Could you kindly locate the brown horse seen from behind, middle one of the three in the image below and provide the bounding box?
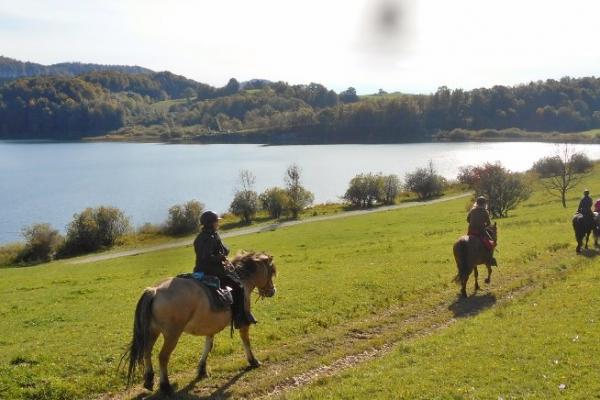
[453,223,498,297]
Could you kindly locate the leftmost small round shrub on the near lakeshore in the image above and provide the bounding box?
[16,224,63,264]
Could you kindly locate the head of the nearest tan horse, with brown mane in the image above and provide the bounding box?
[232,252,277,297]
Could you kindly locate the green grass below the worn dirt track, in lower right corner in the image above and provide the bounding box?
[287,263,600,399]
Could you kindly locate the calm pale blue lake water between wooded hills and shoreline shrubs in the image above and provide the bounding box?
[0,141,600,243]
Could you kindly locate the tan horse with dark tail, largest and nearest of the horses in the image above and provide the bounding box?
[124,253,276,393]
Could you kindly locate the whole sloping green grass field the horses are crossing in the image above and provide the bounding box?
[0,171,600,399]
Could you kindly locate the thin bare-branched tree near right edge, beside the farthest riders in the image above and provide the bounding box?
[540,143,592,208]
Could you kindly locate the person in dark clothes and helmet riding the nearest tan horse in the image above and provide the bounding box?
[194,211,256,329]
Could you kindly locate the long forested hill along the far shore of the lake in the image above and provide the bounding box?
[0,55,600,143]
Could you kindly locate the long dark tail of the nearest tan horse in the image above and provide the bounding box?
[121,288,156,387]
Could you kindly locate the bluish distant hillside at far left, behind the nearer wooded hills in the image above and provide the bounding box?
[0,56,153,80]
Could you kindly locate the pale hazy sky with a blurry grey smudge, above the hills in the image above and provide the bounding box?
[0,0,600,93]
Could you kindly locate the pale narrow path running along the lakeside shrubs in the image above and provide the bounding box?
[69,193,471,264]
